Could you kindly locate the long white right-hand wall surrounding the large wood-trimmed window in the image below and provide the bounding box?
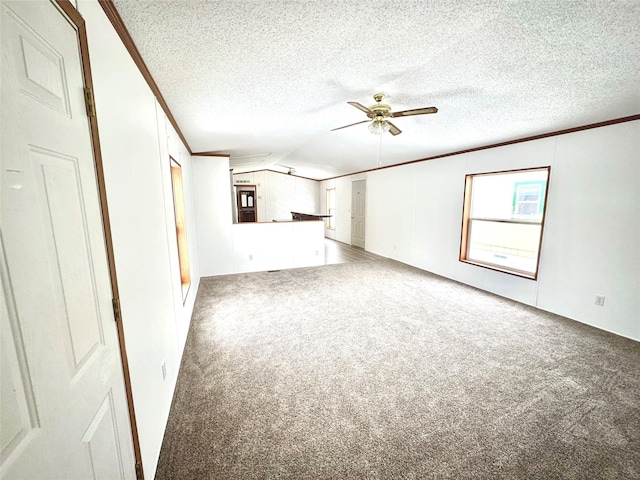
[348,121,640,340]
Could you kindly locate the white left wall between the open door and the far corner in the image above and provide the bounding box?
[78,0,200,472]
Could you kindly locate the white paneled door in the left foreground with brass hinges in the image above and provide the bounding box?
[0,0,135,479]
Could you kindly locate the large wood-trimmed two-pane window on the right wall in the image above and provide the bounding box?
[460,167,550,279]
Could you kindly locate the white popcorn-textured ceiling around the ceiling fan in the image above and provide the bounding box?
[114,0,640,179]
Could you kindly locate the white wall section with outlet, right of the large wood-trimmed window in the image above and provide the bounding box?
[538,122,640,340]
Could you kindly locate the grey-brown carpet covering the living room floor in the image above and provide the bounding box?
[156,260,640,479]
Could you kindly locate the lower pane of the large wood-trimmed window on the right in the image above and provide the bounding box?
[467,220,542,274]
